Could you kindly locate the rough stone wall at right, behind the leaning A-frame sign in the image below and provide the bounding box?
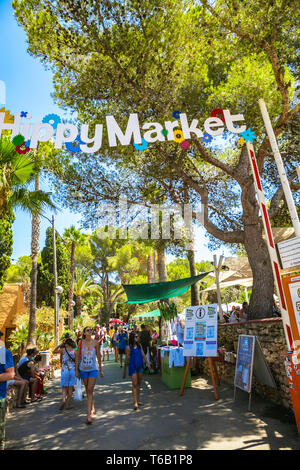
[204,318,292,409]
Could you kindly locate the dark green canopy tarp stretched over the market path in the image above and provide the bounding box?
[123,271,211,304]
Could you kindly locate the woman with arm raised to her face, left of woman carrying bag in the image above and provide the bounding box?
[53,338,76,410]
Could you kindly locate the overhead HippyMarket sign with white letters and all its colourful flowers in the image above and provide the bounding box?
[0,108,255,153]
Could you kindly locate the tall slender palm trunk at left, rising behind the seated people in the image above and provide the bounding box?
[27,174,40,347]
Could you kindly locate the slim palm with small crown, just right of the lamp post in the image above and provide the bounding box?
[63,225,86,330]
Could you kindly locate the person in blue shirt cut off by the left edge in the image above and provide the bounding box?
[0,331,15,450]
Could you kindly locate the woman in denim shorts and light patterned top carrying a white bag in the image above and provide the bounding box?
[75,327,104,424]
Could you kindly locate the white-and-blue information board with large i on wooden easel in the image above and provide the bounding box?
[183,304,218,357]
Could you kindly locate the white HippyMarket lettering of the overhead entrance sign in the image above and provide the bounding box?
[0,109,251,153]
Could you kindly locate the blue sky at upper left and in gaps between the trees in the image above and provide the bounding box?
[0,0,230,261]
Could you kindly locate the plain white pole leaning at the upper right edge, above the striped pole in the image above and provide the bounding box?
[258,99,300,237]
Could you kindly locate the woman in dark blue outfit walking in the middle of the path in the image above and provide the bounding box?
[123,333,151,410]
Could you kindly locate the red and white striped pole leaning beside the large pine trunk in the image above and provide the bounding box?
[246,141,295,351]
